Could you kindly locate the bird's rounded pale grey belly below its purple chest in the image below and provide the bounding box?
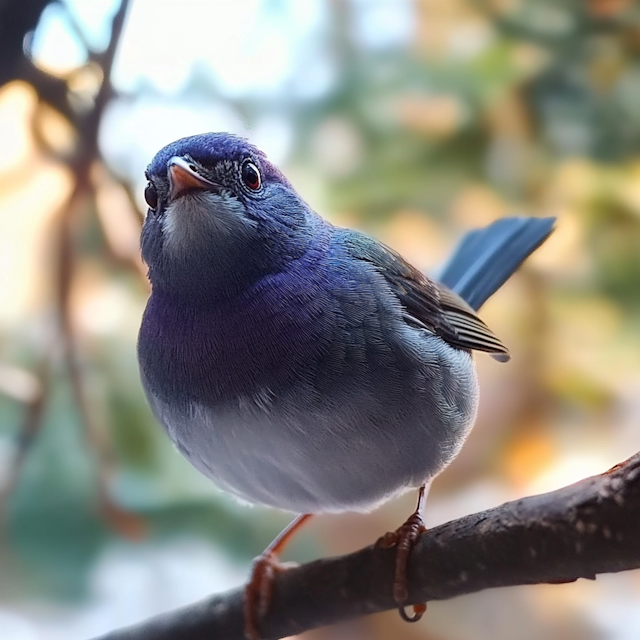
[150,329,478,513]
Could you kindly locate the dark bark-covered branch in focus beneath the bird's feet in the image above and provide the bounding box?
[90,453,640,640]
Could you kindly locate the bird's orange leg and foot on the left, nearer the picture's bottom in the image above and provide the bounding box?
[244,513,311,640]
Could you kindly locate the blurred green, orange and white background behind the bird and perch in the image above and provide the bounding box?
[0,0,640,640]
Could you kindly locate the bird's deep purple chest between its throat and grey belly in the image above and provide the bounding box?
[138,279,331,404]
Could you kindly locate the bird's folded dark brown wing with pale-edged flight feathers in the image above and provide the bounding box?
[338,229,510,362]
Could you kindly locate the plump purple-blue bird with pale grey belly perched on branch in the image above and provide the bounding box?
[137,132,555,640]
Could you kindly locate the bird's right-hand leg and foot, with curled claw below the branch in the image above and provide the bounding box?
[376,483,431,622]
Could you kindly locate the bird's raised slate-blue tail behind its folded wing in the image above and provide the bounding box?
[439,218,556,311]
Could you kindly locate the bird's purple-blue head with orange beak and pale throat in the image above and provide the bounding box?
[142,133,315,299]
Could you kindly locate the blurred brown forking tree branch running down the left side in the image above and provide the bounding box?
[0,0,142,536]
